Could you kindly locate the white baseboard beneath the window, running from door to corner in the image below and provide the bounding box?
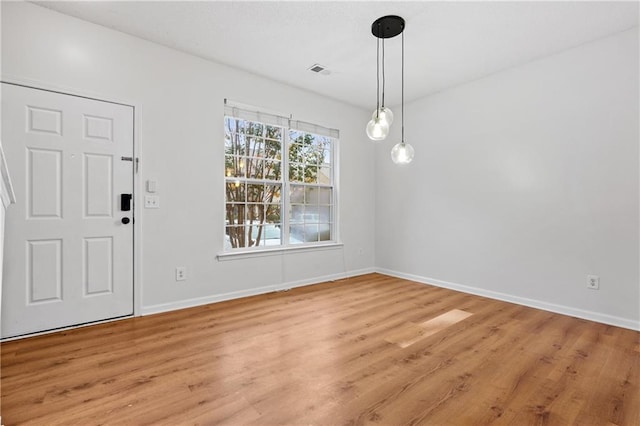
[141,268,376,315]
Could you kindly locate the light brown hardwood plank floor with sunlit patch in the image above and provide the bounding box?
[0,274,640,426]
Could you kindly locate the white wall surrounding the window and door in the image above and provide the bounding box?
[2,2,374,312]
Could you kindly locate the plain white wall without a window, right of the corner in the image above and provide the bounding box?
[376,27,640,329]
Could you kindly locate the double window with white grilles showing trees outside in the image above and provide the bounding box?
[224,102,338,251]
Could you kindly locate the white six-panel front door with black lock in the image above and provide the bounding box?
[1,83,134,338]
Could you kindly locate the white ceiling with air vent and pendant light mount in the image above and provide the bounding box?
[36,1,639,109]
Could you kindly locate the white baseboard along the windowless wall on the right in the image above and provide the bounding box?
[376,268,640,331]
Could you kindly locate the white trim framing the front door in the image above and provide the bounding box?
[0,75,144,330]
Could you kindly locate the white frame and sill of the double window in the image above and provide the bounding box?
[217,100,342,260]
